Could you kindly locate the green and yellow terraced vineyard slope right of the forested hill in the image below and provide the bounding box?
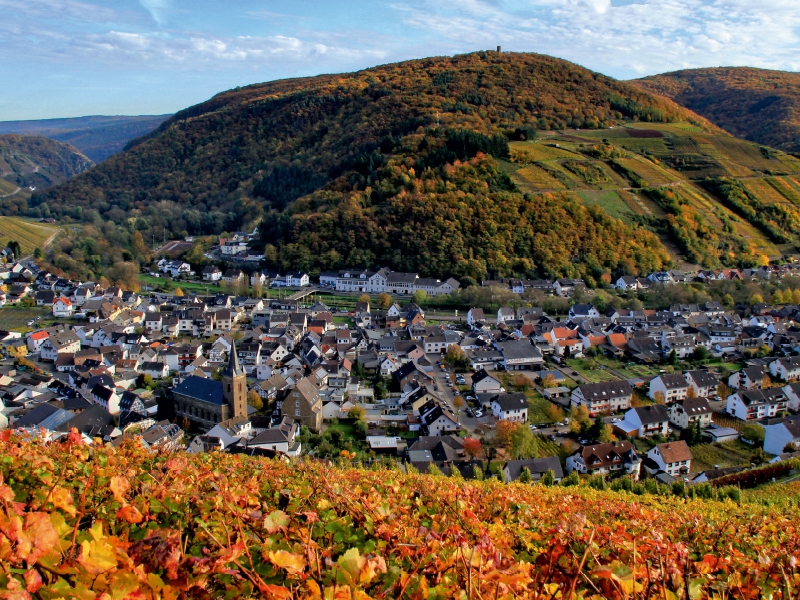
[510,123,800,268]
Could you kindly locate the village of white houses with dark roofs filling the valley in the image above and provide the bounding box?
[0,254,800,492]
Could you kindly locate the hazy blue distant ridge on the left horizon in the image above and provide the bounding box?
[0,115,169,163]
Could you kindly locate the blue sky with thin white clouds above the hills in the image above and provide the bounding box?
[0,0,800,121]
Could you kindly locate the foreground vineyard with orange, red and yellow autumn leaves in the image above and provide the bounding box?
[0,431,800,600]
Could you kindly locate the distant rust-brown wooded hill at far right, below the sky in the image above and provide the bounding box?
[631,67,800,152]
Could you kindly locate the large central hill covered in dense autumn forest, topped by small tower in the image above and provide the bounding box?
[25,52,716,284]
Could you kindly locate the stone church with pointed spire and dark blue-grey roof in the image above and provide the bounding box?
[174,346,247,430]
